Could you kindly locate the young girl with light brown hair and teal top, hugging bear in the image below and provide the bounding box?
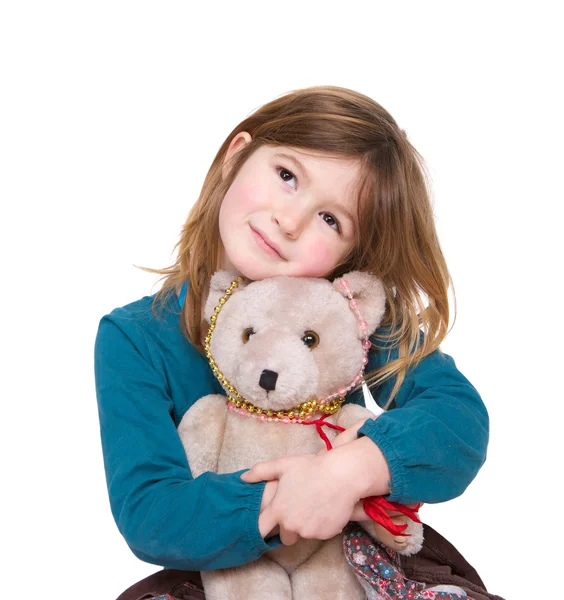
[95,86,488,584]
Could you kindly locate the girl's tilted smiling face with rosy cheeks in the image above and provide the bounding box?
[219,132,360,280]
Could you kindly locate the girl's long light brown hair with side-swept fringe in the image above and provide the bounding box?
[139,86,454,406]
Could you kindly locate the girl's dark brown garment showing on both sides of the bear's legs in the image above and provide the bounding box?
[117,525,503,600]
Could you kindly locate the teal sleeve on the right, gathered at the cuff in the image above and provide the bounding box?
[359,340,489,503]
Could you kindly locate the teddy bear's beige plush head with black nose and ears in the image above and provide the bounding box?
[205,271,386,410]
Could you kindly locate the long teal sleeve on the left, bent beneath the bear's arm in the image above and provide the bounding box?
[95,309,280,570]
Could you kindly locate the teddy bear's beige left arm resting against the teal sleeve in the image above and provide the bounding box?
[178,394,227,477]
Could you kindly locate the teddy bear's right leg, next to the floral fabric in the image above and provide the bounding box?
[290,534,366,600]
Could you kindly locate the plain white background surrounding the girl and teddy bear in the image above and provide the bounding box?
[0,0,564,600]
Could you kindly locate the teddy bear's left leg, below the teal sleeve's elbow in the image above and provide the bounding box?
[202,556,292,600]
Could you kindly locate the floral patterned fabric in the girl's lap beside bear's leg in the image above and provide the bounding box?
[343,524,472,600]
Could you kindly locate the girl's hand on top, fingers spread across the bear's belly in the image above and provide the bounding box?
[241,452,359,546]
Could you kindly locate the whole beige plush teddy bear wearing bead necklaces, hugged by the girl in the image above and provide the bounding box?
[178,271,422,600]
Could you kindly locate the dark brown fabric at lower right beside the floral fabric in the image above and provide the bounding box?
[401,524,503,600]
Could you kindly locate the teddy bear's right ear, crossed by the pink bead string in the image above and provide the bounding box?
[333,271,386,338]
